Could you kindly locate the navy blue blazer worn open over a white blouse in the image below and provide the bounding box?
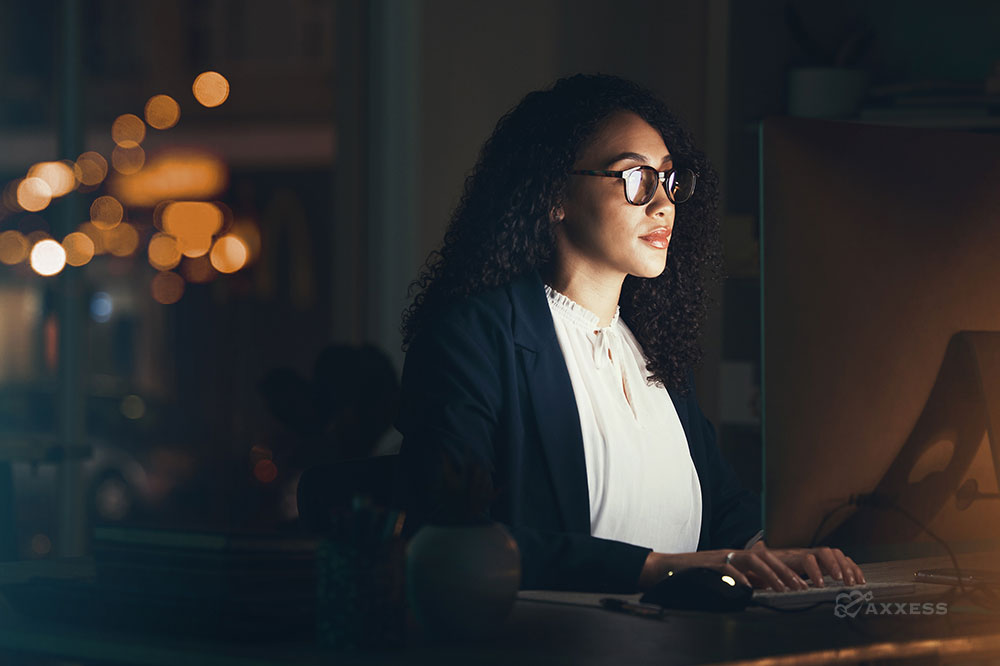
[395,271,761,594]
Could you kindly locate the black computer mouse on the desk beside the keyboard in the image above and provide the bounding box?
[639,567,753,612]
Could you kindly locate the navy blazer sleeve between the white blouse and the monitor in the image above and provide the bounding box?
[689,373,762,550]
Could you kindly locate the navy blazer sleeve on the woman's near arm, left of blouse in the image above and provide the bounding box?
[396,310,652,594]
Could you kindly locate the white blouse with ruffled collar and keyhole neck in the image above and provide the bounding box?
[545,285,701,553]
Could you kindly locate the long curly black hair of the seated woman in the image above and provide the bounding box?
[401,74,723,395]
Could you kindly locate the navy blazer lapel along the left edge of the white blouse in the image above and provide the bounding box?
[510,270,590,534]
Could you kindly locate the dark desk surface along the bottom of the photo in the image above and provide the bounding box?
[0,553,1000,666]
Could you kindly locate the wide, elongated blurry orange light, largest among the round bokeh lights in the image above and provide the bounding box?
[109,149,229,208]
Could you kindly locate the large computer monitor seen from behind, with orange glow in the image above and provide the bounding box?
[760,118,1000,562]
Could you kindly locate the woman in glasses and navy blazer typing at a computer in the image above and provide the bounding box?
[396,75,864,593]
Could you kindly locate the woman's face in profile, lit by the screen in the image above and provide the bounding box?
[556,111,674,279]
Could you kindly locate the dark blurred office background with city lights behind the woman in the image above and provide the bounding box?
[0,0,1000,559]
